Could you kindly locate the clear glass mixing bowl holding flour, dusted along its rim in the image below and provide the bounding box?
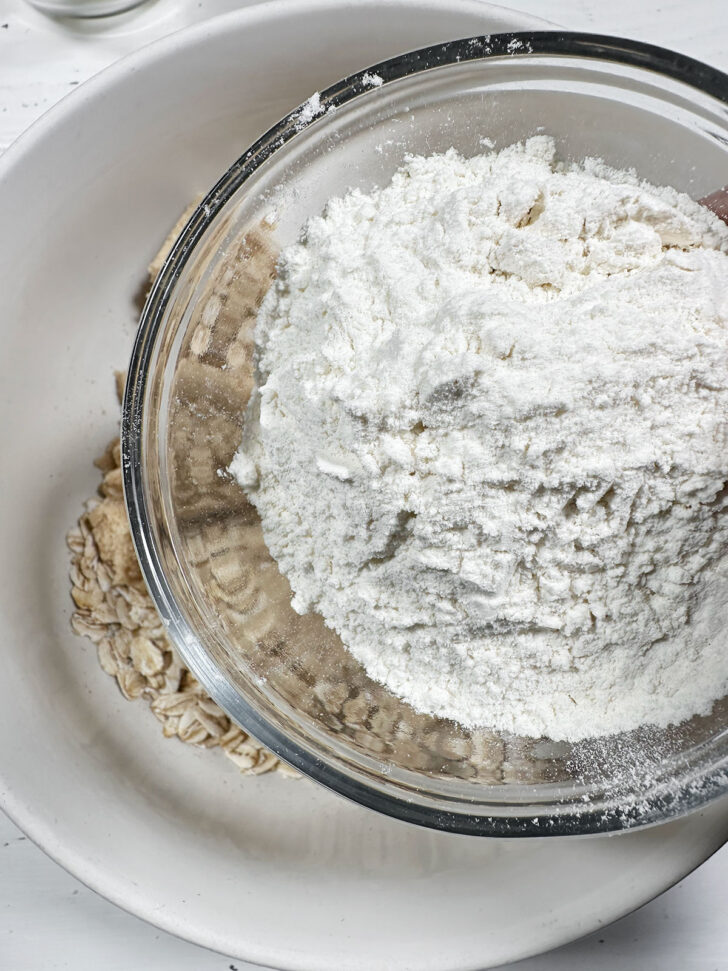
[123,32,728,836]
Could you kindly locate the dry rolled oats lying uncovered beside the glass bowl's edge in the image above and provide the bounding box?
[67,207,298,777]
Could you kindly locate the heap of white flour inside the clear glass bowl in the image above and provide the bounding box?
[232,137,728,740]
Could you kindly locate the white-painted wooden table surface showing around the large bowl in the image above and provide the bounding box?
[0,0,728,971]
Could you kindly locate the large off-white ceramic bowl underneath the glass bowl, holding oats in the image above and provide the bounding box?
[0,0,728,971]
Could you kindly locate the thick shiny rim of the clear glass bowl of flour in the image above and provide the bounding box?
[121,31,728,837]
